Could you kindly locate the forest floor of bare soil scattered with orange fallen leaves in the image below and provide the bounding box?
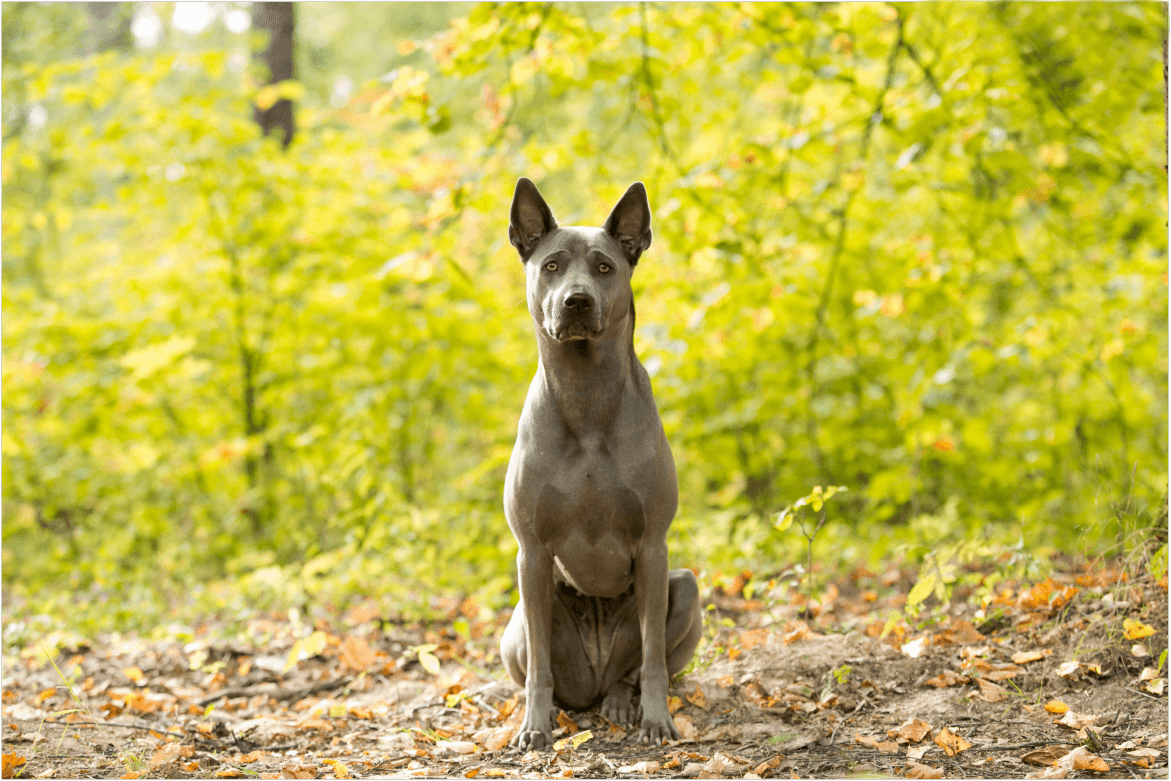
[0,562,1167,779]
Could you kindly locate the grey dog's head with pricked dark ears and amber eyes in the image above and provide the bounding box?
[508,178,651,342]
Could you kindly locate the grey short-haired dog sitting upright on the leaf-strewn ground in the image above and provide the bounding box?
[500,178,703,749]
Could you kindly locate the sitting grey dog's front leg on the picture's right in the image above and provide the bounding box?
[635,540,679,746]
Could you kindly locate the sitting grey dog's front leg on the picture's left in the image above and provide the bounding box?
[512,547,553,749]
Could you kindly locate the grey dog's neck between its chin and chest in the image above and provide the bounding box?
[536,313,635,437]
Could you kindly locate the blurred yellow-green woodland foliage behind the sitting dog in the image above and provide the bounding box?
[2,2,1167,642]
